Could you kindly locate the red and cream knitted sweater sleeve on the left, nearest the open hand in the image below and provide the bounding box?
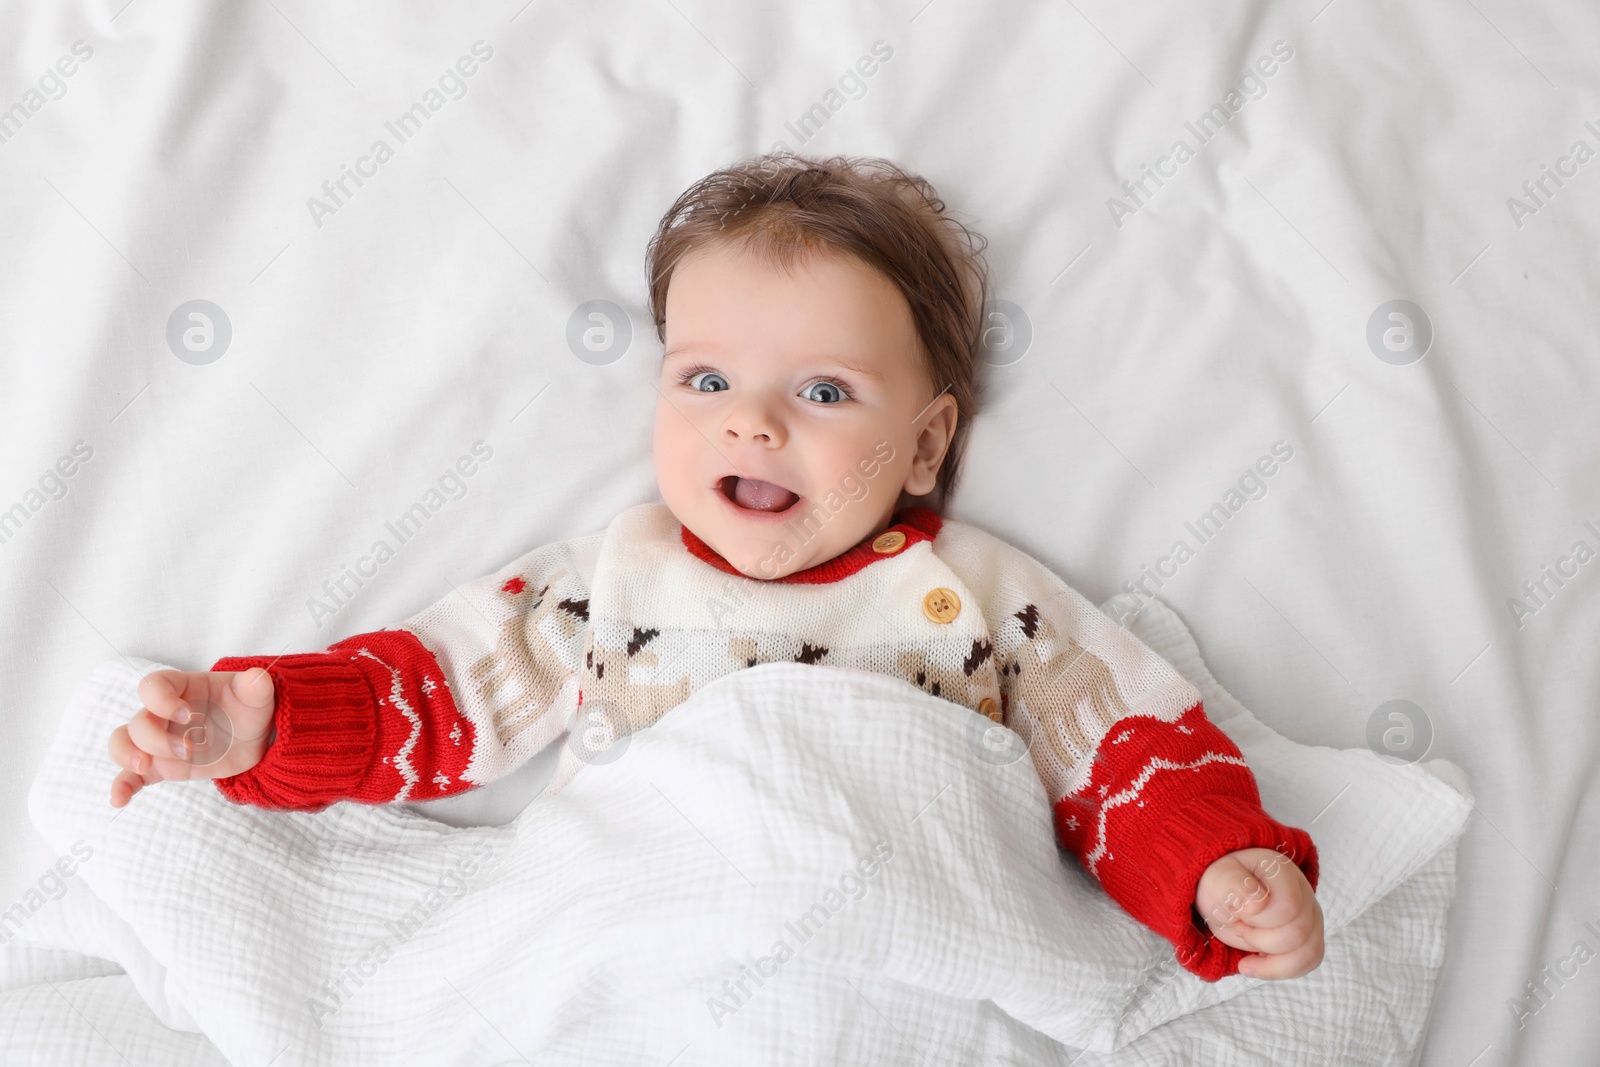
[211,534,600,811]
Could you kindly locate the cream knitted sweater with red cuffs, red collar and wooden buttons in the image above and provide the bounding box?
[211,504,1317,981]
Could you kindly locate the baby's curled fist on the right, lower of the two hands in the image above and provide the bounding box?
[1195,848,1322,977]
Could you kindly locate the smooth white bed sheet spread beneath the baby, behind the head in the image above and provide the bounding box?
[0,0,1600,1067]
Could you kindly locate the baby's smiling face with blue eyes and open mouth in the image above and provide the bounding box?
[654,246,955,579]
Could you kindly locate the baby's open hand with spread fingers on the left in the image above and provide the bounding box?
[110,667,274,808]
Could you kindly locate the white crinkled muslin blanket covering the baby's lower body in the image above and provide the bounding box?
[0,601,1470,1067]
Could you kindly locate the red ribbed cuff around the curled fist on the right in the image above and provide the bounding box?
[1102,793,1317,982]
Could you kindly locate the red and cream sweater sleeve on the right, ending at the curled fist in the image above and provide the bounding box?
[953,534,1317,982]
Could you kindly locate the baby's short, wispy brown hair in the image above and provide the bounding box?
[646,152,987,506]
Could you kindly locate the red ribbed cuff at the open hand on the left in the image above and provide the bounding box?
[211,653,378,811]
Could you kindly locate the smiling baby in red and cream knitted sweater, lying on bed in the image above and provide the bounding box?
[110,154,1323,981]
